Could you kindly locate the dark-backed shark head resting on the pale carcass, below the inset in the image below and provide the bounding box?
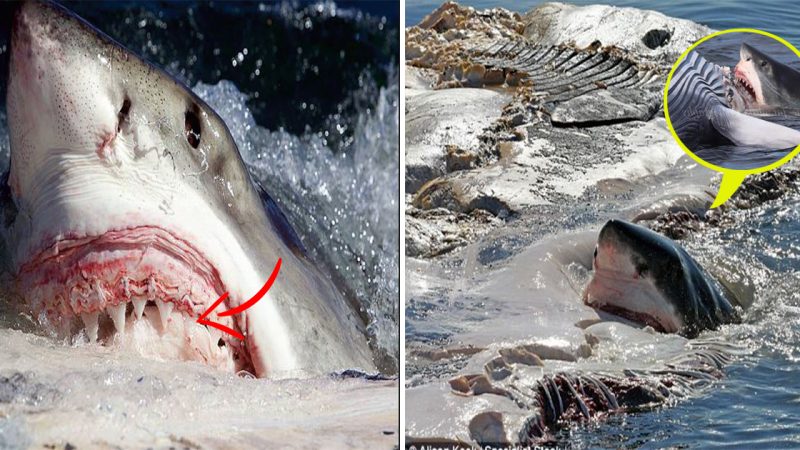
[583,220,736,336]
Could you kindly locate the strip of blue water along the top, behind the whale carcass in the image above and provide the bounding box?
[406,0,800,46]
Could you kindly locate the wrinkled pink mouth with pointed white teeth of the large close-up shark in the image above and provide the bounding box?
[18,226,254,373]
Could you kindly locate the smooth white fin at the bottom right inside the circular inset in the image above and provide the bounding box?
[708,105,800,149]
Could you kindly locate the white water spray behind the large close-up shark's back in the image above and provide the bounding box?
[194,68,399,373]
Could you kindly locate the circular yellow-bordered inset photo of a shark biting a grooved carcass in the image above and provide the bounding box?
[664,30,800,171]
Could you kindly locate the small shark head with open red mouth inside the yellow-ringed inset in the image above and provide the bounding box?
[734,43,800,108]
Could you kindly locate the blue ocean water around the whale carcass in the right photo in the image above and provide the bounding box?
[406,0,800,449]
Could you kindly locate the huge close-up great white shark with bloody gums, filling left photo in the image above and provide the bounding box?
[3,1,375,378]
